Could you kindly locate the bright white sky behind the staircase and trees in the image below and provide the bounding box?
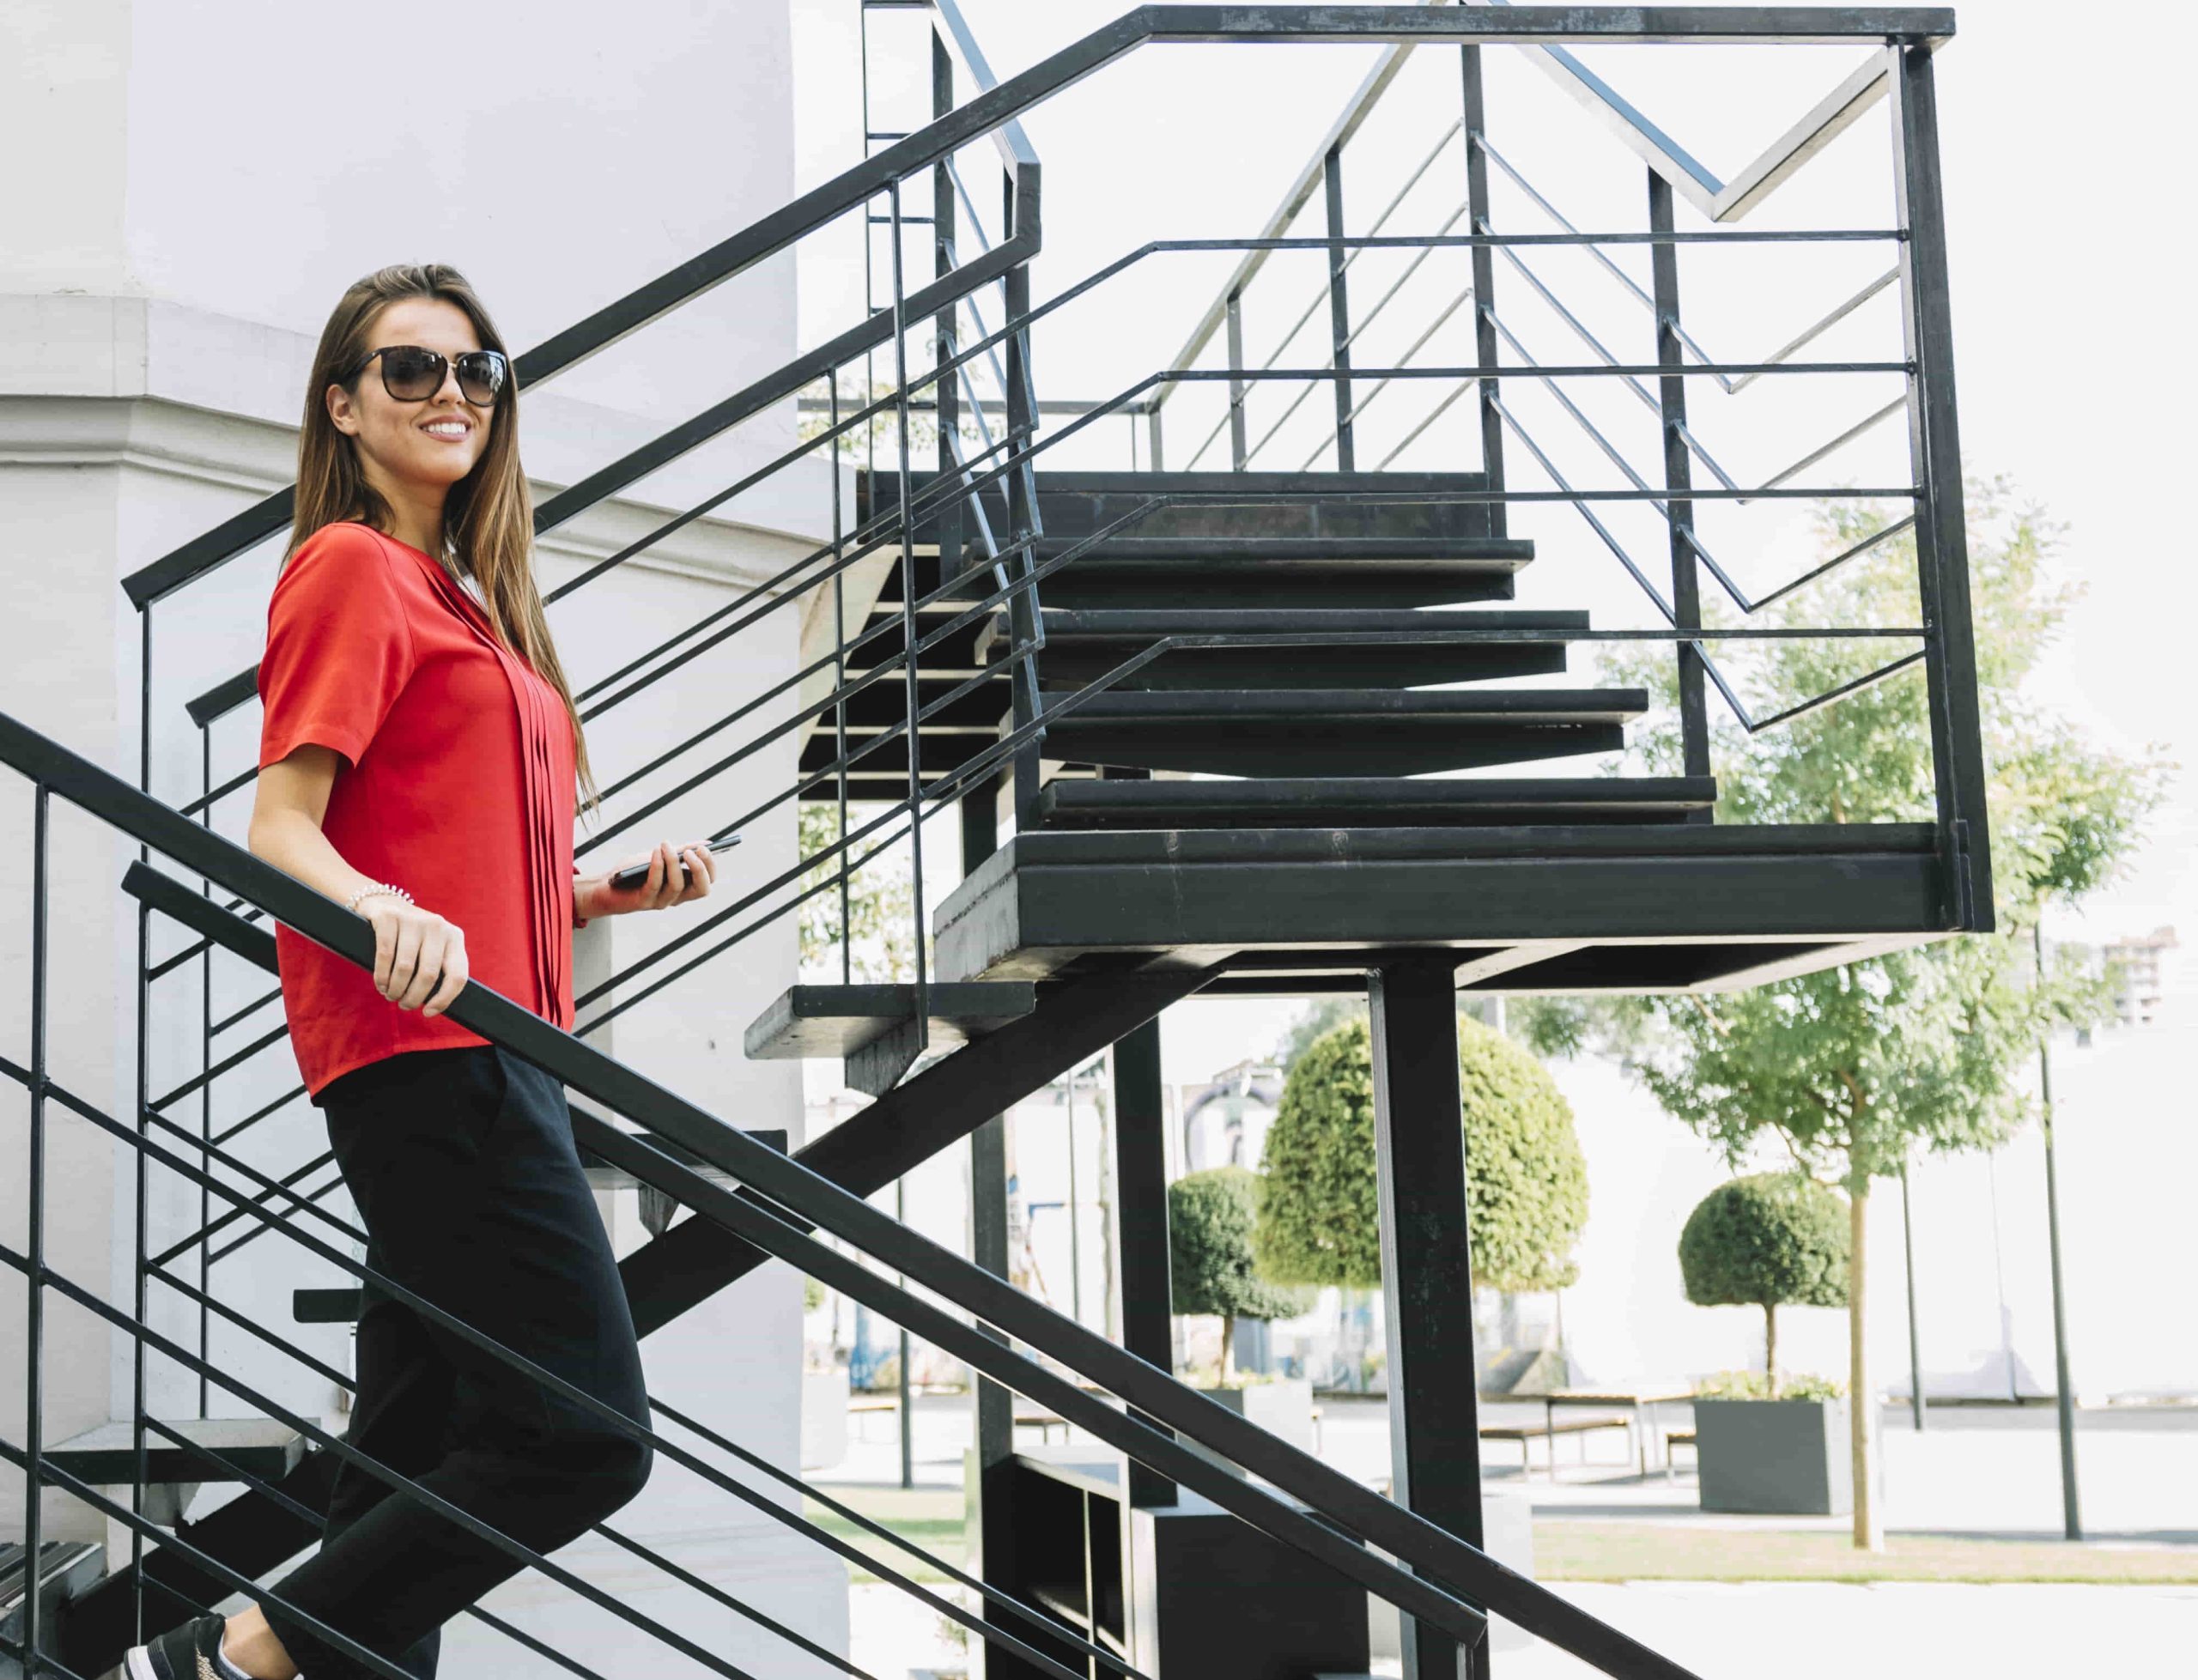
[793,0,2198,1387]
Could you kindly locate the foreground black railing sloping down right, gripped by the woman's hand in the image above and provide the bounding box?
[0,714,1714,1680]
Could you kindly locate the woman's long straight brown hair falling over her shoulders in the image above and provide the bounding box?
[282,262,596,810]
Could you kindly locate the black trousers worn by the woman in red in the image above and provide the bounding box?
[262,1045,653,1680]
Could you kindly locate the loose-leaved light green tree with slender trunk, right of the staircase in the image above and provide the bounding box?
[1515,479,2170,1550]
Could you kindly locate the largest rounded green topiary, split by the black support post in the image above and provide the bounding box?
[1253,1016,1587,1291]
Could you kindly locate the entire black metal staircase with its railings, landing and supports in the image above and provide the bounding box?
[0,0,1991,1680]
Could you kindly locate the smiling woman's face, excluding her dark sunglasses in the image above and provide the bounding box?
[327,297,490,506]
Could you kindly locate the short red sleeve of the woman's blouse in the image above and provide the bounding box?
[259,521,413,770]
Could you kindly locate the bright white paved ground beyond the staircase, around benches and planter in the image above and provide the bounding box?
[811,1397,2198,1680]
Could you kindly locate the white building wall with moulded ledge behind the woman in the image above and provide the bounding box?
[0,0,851,1676]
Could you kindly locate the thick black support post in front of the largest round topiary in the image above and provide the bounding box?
[1367,955,1488,1680]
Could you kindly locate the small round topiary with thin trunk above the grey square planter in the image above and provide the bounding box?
[1679,1172,1846,1401]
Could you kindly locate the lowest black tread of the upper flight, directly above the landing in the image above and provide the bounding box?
[1037,776,1716,829]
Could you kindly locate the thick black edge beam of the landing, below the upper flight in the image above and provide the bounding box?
[938,822,1943,979]
